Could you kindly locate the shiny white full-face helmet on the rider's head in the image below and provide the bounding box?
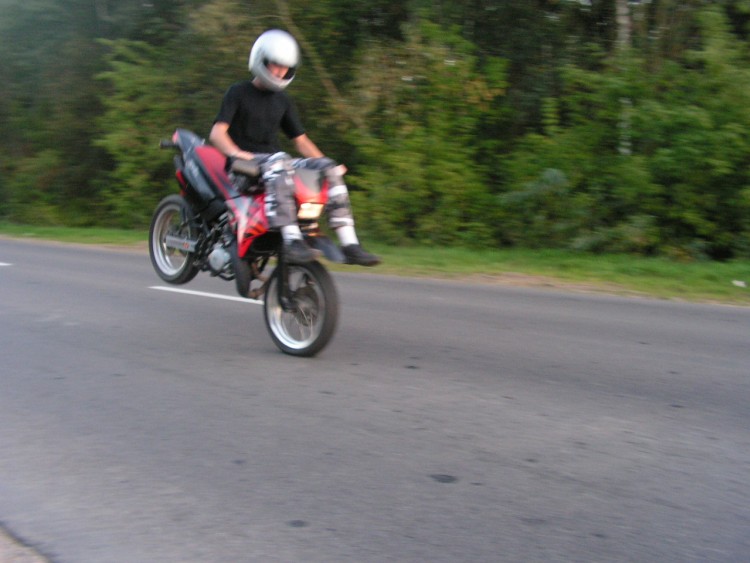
[248,29,299,92]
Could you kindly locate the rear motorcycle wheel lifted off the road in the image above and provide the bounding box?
[148,195,199,284]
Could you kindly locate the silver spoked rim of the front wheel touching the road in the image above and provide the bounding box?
[266,266,325,350]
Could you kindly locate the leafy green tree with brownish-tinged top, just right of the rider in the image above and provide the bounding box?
[350,20,505,246]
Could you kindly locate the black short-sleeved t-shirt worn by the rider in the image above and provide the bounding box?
[214,80,305,153]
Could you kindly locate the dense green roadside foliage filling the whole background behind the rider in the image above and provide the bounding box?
[0,0,750,259]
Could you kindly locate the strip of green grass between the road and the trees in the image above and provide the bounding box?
[0,223,750,306]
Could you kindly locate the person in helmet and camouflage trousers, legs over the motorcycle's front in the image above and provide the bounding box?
[209,29,380,266]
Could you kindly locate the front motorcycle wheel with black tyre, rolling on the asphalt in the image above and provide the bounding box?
[263,262,339,357]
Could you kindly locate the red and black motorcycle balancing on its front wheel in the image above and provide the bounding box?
[149,129,344,357]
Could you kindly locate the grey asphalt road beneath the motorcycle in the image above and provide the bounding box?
[0,240,750,563]
